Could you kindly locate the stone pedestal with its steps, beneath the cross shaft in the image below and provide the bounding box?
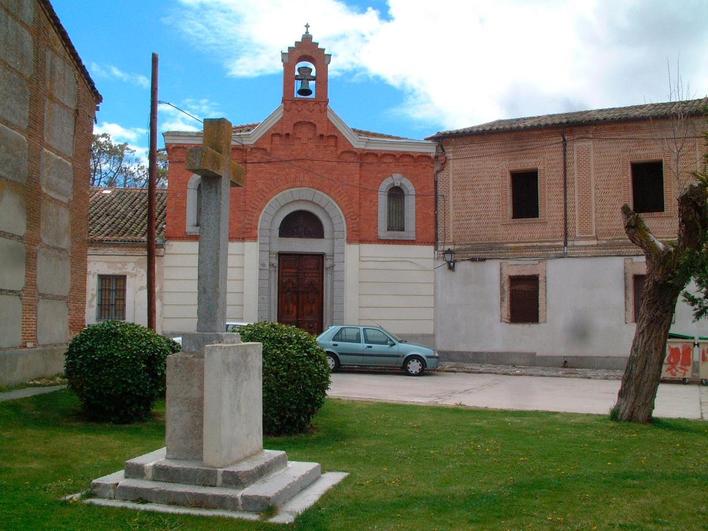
[89,333,345,521]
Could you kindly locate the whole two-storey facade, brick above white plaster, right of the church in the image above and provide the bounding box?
[433,100,708,369]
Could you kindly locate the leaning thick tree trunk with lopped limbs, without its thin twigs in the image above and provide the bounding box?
[612,120,708,422]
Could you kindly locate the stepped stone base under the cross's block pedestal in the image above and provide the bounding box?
[91,448,332,513]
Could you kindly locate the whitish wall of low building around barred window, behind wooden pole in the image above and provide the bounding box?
[86,247,163,332]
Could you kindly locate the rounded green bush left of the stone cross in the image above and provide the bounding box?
[64,321,180,423]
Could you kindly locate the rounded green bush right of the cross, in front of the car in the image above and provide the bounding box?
[238,323,329,435]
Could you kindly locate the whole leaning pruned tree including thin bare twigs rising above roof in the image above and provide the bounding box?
[611,86,708,422]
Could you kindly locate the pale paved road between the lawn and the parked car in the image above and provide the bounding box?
[329,372,708,419]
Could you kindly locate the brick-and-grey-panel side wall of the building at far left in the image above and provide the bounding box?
[0,0,100,384]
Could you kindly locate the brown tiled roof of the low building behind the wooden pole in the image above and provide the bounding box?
[88,188,167,243]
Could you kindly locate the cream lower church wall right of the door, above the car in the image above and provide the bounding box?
[356,244,435,335]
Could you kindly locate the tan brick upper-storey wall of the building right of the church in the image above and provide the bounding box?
[438,117,705,257]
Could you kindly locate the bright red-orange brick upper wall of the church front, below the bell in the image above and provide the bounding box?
[166,101,435,245]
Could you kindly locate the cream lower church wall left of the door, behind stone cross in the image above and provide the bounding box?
[162,242,246,333]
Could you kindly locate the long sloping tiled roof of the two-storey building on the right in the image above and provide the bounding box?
[428,98,708,140]
